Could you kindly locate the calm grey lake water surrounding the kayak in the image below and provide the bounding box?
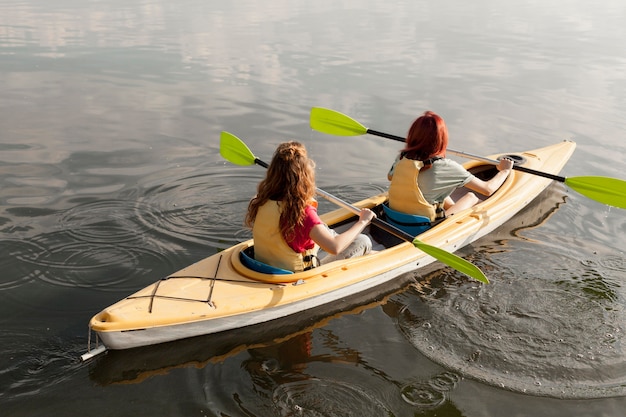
[0,0,626,417]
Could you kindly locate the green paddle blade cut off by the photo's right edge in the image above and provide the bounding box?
[564,176,626,209]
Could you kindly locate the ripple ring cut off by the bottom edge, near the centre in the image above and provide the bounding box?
[272,378,391,417]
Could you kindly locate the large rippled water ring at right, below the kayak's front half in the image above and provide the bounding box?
[398,245,626,398]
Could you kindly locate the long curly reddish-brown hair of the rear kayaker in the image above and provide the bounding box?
[245,141,315,241]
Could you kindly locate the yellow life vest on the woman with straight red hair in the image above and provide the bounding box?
[389,158,443,222]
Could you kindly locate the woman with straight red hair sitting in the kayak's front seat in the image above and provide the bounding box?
[387,111,513,222]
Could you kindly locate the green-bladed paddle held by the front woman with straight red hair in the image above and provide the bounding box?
[310,107,626,208]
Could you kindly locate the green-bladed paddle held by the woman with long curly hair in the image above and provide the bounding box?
[220,132,489,284]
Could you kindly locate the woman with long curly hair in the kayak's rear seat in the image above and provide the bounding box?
[245,141,375,272]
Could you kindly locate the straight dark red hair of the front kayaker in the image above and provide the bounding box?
[402,111,448,161]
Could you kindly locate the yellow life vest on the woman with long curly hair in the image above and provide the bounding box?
[252,200,319,272]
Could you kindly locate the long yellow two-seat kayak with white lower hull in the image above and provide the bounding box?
[83,141,576,356]
